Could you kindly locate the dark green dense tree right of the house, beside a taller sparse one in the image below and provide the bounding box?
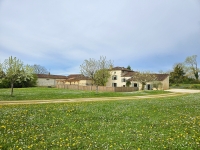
[169,63,185,84]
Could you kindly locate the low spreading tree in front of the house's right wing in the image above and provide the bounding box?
[132,71,157,90]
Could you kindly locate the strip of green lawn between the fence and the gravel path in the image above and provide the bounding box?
[0,88,170,101]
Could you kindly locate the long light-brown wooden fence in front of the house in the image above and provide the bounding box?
[57,84,138,92]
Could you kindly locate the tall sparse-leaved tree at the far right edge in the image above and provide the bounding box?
[184,55,200,80]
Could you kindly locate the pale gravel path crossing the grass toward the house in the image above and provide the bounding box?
[0,91,188,105]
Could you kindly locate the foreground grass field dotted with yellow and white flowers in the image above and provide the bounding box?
[0,94,200,150]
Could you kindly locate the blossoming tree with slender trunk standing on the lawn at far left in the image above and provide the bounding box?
[0,56,33,96]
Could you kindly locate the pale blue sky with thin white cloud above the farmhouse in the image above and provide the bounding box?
[0,0,200,75]
